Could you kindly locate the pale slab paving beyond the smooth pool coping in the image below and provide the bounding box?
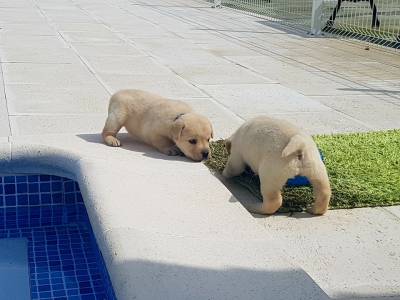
[0,0,400,299]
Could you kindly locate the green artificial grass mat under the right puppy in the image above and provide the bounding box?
[206,130,400,212]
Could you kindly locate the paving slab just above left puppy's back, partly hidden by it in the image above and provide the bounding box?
[97,73,206,98]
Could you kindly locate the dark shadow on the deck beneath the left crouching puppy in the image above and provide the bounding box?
[77,133,196,163]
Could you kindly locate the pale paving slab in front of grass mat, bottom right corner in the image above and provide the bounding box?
[256,208,400,299]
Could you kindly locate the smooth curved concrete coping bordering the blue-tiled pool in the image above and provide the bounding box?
[1,134,329,299]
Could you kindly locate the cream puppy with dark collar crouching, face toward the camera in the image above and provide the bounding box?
[102,90,213,161]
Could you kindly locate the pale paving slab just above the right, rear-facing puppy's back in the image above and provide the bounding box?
[201,84,331,119]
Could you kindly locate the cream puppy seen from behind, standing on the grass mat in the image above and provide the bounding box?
[222,116,331,215]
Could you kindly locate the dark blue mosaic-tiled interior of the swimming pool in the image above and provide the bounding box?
[0,175,116,300]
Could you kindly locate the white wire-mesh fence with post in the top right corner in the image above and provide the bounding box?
[211,0,400,49]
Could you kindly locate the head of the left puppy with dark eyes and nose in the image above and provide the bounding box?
[172,113,213,161]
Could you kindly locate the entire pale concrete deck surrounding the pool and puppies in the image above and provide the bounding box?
[0,0,400,299]
